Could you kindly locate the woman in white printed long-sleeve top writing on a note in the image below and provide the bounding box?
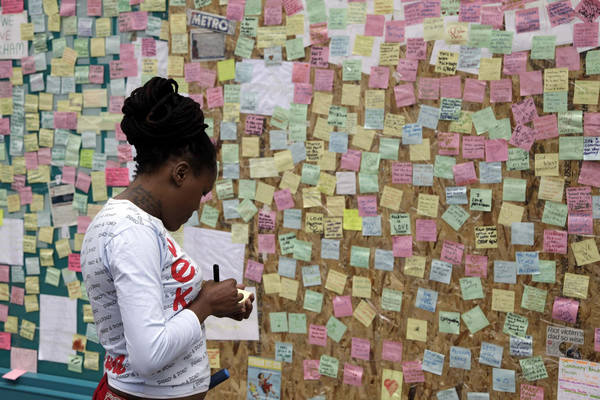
[81,77,254,400]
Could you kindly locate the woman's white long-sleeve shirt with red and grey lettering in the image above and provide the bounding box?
[81,199,210,398]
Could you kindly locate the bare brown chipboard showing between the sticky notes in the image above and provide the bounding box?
[166,5,600,399]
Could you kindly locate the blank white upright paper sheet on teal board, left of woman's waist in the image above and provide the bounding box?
[38,294,77,364]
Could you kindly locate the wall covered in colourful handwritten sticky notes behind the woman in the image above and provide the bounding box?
[0,0,600,400]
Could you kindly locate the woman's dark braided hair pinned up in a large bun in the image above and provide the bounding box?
[121,76,217,175]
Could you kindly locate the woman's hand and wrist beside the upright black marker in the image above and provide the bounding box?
[189,279,245,322]
